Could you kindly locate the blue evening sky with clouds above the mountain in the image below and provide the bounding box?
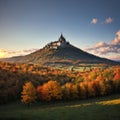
[0,0,120,60]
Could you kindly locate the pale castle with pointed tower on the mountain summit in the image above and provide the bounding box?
[44,34,69,49]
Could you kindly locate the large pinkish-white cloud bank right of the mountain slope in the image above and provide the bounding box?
[85,31,120,59]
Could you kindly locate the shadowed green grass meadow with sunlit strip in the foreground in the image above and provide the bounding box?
[0,95,120,120]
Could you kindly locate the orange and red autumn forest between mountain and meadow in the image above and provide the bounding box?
[0,62,120,104]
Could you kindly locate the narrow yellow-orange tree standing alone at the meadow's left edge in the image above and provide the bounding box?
[21,82,37,104]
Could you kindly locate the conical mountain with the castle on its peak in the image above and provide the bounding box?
[0,35,117,65]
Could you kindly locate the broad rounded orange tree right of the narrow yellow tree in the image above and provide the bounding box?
[41,80,62,101]
